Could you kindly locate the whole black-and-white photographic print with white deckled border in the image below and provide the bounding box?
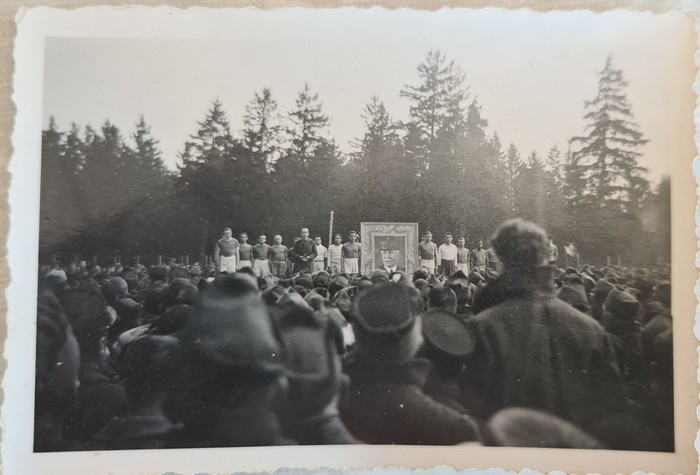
[2,4,695,475]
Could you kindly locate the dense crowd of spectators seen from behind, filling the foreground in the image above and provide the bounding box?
[34,220,674,452]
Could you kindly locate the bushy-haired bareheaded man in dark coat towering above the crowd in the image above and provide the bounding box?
[462,220,627,450]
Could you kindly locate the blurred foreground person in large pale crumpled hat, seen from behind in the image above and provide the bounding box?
[164,292,284,438]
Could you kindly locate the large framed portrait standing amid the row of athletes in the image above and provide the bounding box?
[360,223,418,274]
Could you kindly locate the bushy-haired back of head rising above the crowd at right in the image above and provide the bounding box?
[491,219,548,269]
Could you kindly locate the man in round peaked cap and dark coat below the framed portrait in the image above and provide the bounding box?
[340,283,478,445]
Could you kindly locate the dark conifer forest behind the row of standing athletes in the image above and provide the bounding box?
[39,51,670,265]
